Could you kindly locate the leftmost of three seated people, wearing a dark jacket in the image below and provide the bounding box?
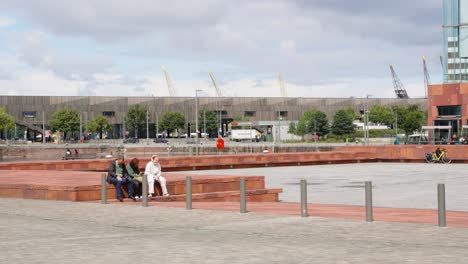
[108,156,136,202]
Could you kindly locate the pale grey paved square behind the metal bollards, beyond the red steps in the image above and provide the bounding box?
[170,163,468,211]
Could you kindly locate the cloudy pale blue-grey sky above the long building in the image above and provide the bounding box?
[0,0,442,98]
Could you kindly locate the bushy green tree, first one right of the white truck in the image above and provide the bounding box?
[296,109,330,136]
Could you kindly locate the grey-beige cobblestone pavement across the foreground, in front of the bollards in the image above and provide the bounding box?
[0,198,468,264]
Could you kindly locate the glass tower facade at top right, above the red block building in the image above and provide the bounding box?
[443,0,468,83]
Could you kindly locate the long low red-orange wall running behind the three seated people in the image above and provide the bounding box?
[0,151,373,171]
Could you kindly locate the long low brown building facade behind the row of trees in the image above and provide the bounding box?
[0,96,427,138]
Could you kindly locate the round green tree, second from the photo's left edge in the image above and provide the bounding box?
[49,108,80,139]
